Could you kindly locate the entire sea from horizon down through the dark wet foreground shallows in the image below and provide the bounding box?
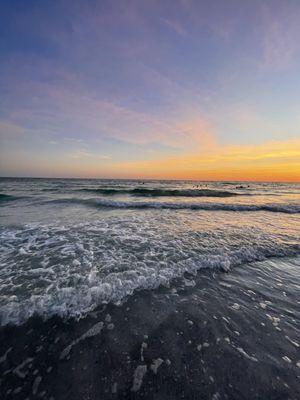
[0,178,300,400]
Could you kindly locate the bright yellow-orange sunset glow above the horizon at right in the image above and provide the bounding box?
[108,139,300,182]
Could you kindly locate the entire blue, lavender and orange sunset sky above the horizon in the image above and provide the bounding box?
[0,0,300,181]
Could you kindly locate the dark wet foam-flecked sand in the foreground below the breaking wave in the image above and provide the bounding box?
[0,261,300,400]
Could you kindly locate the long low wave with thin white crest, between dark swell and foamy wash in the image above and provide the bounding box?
[47,198,300,214]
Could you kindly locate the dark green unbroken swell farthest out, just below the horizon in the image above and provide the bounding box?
[80,188,242,197]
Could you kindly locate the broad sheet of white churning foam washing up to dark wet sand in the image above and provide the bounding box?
[0,215,300,325]
